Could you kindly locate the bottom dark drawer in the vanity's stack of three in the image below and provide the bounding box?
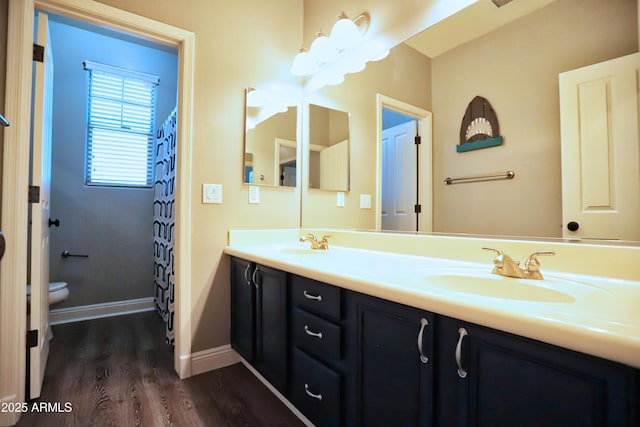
[291,349,342,427]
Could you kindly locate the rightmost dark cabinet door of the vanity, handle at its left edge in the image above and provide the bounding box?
[437,318,637,427]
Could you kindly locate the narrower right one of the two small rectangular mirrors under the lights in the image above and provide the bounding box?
[309,104,349,191]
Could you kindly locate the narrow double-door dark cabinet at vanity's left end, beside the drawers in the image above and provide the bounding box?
[231,258,288,394]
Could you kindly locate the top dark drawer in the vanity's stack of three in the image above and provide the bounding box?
[291,275,340,320]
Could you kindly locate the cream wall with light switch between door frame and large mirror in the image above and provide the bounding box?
[94,0,302,352]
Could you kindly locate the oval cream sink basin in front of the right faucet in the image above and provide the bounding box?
[426,273,575,303]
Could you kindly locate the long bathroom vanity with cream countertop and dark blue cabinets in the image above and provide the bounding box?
[226,232,640,426]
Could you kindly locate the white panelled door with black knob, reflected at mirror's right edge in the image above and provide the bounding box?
[560,53,640,240]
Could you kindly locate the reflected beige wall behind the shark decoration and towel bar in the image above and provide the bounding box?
[432,0,638,237]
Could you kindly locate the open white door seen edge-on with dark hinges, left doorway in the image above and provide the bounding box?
[29,12,53,398]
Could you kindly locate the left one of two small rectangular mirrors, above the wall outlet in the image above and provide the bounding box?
[243,88,299,187]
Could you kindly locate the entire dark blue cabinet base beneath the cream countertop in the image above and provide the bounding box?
[231,258,640,427]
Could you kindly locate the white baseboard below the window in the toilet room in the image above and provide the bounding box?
[49,297,156,325]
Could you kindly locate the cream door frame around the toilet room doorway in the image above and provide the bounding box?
[0,0,195,425]
